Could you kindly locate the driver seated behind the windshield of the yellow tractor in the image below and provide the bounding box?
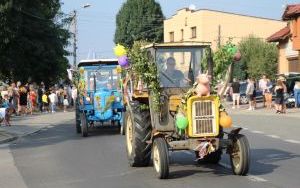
[161,57,184,87]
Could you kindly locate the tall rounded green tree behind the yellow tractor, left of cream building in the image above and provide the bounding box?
[114,0,164,47]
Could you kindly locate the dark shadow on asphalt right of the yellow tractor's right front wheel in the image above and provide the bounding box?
[250,149,300,175]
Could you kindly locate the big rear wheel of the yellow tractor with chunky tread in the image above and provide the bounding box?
[125,102,152,167]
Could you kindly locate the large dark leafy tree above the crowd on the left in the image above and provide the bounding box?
[0,0,69,84]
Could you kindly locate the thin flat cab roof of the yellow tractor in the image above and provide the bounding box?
[144,41,211,48]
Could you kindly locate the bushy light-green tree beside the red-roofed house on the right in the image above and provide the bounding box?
[238,36,278,79]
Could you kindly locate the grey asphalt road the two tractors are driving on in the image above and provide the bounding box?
[0,111,300,188]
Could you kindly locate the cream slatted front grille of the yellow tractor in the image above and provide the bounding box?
[192,100,217,136]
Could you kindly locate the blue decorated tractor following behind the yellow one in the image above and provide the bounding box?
[76,59,125,137]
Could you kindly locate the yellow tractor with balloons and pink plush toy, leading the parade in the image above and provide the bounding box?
[123,42,250,179]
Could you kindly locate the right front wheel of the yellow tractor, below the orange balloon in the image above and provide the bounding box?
[229,134,250,176]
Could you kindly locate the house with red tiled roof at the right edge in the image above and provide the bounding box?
[267,4,300,74]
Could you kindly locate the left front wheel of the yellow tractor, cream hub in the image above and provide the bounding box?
[152,137,169,179]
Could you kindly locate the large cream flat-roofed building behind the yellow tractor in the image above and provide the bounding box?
[164,8,286,50]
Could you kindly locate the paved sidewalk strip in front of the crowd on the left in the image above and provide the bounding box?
[0,112,75,144]
